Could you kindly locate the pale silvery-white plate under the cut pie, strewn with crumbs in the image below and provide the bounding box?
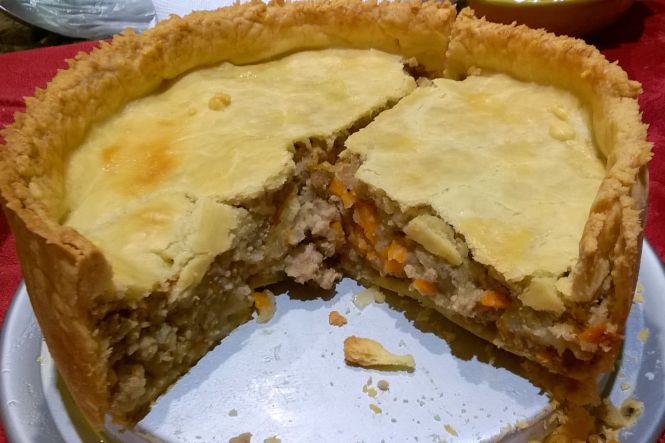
[0,243,665,443]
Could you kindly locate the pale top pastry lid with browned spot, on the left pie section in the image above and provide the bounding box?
[64,49,415,296]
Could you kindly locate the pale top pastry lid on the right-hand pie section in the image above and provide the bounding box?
[346,75,605,281]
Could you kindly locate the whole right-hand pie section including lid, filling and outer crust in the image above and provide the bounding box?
[330,11,650,388]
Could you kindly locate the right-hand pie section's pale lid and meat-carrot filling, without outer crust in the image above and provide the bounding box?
[336,74,618,378]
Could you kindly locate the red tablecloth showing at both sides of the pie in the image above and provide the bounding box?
[0,0,665,443]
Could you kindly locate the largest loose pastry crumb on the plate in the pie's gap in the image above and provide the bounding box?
[344,335,416,371]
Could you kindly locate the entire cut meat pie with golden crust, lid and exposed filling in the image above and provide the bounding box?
[2,2,650,432]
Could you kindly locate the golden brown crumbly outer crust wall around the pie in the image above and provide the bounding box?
[0,0,650,426]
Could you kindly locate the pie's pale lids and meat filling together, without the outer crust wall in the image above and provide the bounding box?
[63,50,612,422]
